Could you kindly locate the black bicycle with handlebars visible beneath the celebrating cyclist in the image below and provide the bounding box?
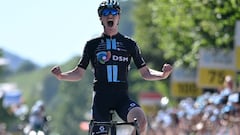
[89,110,140,135]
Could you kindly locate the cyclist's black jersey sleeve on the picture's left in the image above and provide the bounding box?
[78,43,90,69]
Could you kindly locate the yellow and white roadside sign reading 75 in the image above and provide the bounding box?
[197,48,235,88]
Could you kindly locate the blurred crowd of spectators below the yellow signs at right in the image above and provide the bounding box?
[149,76,240,135]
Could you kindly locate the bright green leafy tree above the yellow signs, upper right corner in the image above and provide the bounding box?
[134,0,240,67]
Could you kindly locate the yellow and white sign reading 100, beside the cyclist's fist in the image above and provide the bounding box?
[171,67,202,97]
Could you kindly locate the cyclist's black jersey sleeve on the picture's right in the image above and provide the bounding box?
[132,42,146,69]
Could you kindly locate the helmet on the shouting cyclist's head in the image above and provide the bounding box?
[98,0,120,16]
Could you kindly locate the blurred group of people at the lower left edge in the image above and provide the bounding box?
[0,100,51,135]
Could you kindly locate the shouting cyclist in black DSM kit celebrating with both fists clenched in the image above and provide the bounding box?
[51,0,172,135]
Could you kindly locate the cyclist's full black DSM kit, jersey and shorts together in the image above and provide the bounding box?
[78,33,146,134]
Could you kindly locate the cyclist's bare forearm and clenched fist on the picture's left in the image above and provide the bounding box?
[51,66,85,81]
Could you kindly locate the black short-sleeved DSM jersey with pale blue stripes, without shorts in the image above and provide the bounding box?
[78,33,146,91]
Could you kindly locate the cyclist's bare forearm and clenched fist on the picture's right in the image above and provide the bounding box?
[139,64,172,80]
